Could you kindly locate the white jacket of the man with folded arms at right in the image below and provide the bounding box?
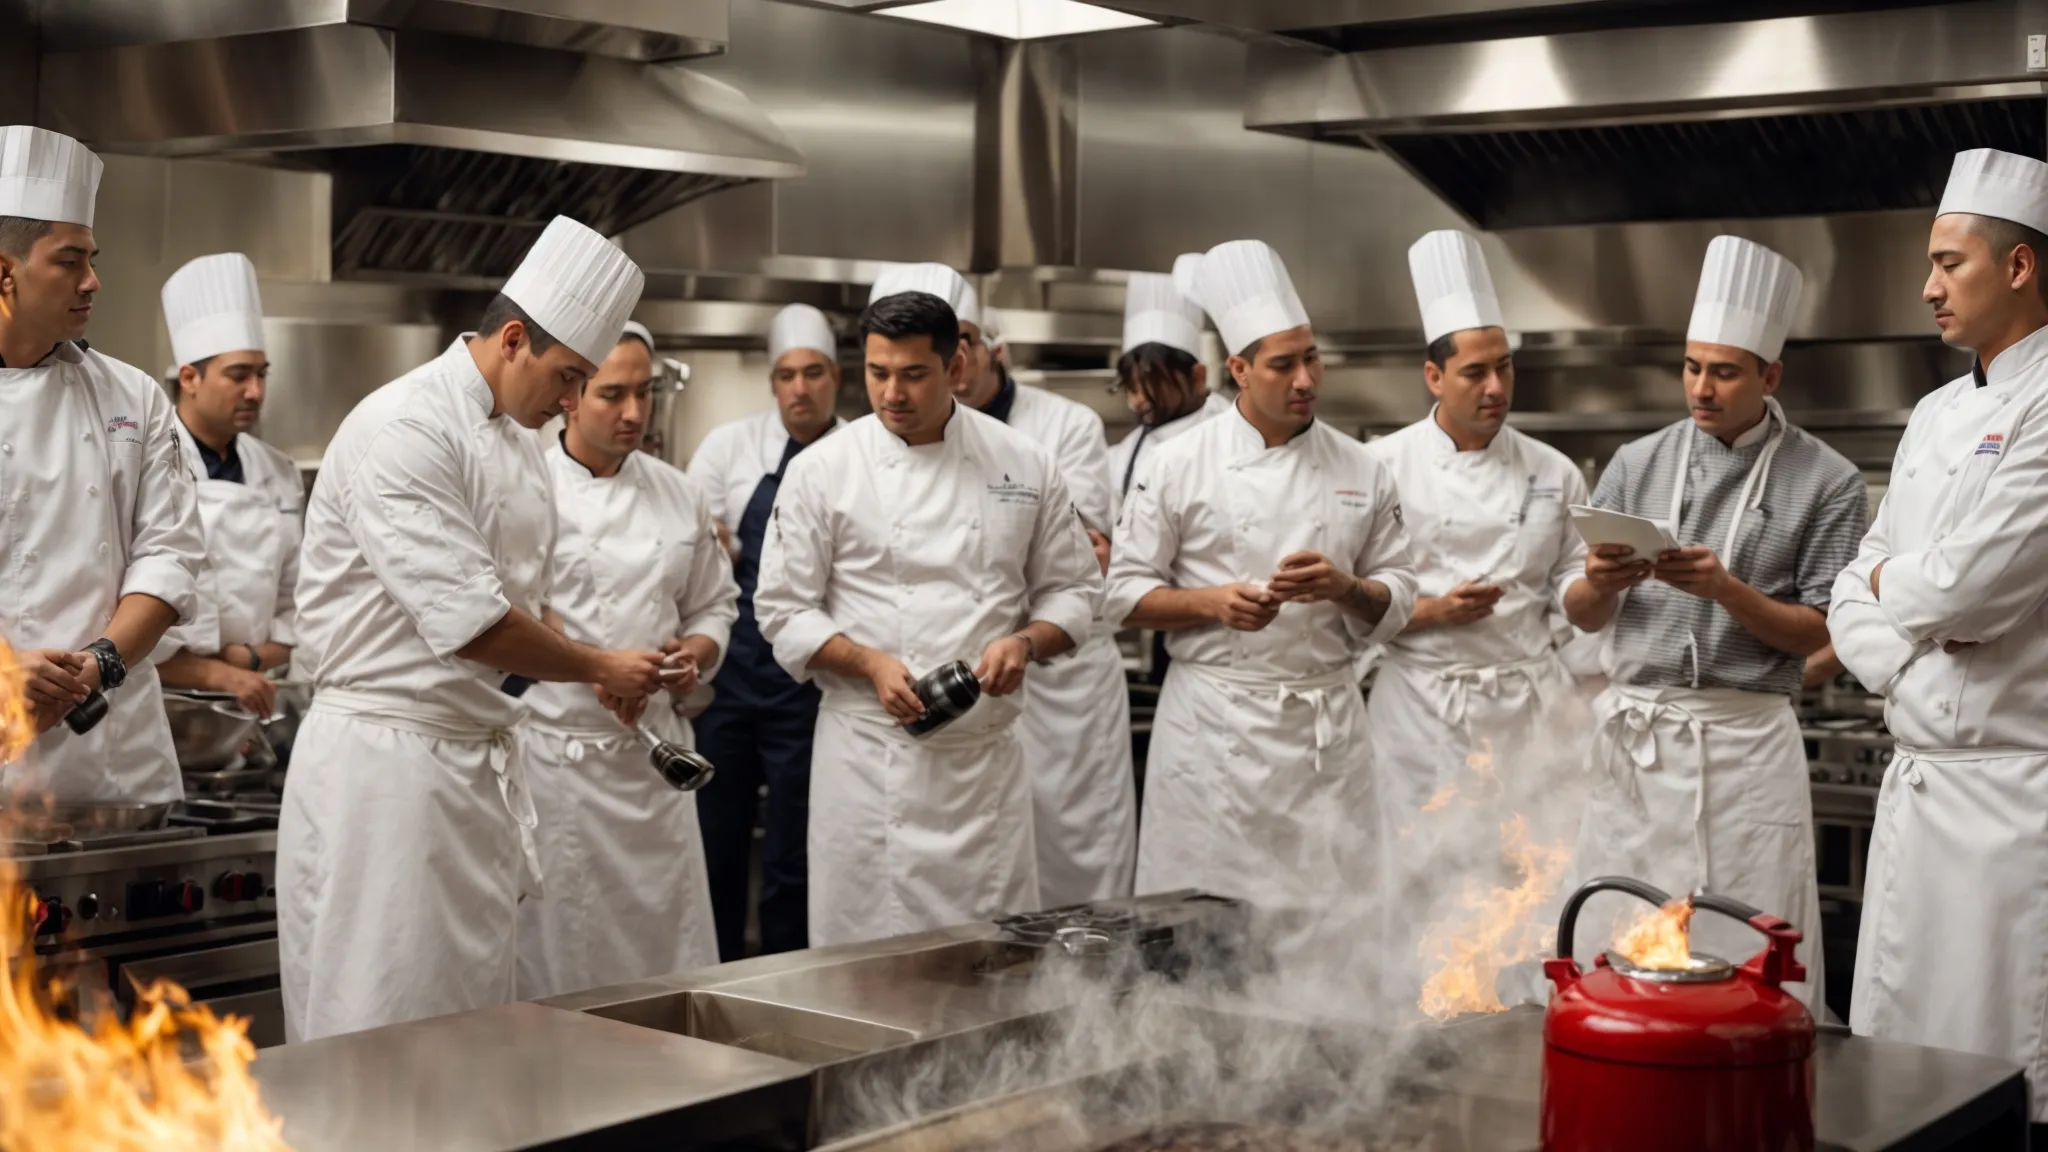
[1829,328,2048,750]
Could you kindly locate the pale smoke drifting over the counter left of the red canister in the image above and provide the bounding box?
[821,676,1589,1152]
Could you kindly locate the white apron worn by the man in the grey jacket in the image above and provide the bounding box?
[1569,683,1825,1017]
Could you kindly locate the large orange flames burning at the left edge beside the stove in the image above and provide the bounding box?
[0,642,289,1152]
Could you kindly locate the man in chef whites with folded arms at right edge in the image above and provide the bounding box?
[1829,150,2048,1138]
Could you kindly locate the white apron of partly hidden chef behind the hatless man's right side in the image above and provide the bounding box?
[1018,629,1139,908]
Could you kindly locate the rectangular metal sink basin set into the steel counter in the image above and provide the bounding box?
[590,992,915,1066]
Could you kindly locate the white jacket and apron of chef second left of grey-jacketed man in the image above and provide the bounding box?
[1104,408,1415,910]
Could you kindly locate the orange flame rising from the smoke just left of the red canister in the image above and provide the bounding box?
[1419,816,1573,1021]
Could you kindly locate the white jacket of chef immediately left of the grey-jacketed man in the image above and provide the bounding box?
[1366,410,1585,668]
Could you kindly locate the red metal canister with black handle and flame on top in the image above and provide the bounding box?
[1542,877,1815,1152]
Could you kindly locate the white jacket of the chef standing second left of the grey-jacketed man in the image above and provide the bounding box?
[1104,406,1415,681]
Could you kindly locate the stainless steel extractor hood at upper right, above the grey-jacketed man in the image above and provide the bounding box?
[1112,0,2048,230]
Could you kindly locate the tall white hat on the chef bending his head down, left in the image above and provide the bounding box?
[504,215,647,365]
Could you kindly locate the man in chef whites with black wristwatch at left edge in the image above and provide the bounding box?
[0,125,205,804]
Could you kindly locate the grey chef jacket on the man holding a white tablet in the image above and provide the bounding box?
[1593,414,1870,697]
